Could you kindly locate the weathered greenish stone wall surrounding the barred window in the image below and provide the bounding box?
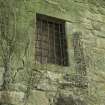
[0,0,105,105]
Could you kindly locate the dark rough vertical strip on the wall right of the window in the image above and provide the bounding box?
[73,32,87,76]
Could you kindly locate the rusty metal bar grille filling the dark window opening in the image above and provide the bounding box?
[35,14,68,66]
